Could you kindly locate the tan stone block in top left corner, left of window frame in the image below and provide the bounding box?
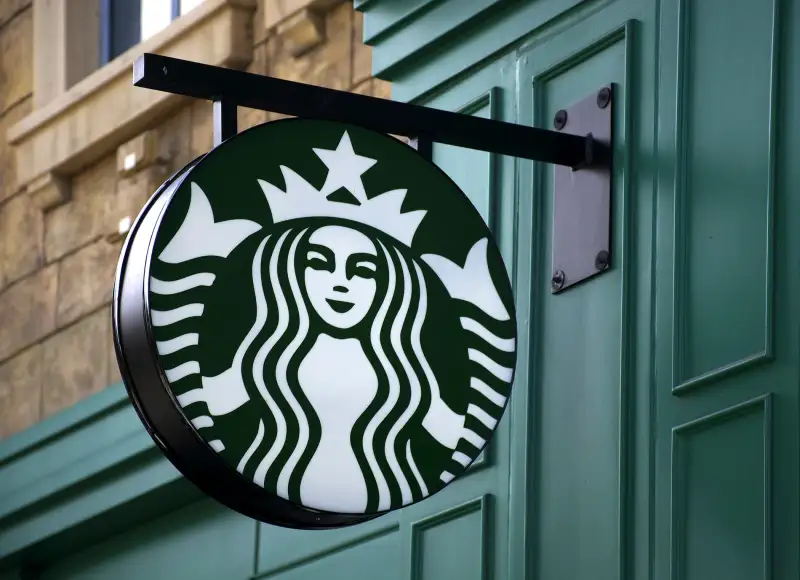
[0,8,33,112]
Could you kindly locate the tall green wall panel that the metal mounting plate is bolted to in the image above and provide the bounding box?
[518,10,633,580]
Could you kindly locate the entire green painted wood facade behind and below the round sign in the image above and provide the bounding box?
[0,0,800,580]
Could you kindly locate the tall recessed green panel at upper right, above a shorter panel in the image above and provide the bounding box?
[673,0,778,389]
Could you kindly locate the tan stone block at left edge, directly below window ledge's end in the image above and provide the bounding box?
[0,188,44,288]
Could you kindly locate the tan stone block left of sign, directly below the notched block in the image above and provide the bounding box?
[56,239,122,327]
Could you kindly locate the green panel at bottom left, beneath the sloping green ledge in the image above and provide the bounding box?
[37,499,256,580]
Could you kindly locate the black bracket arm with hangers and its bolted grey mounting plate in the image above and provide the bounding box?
[133,53,613,292]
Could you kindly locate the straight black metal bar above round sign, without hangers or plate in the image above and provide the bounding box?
[133,53,610,168]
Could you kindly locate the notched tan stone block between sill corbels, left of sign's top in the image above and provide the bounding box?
[44,154,117,262]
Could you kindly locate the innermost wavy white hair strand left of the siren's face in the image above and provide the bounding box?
[275,230,309,499]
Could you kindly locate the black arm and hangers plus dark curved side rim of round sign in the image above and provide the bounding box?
[113,54,613,529]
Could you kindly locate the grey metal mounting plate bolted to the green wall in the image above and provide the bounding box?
[551,85,614,293]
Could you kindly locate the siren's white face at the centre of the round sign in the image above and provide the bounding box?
[305,226,378,329]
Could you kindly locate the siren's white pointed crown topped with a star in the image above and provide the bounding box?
[258,131,426,247]
